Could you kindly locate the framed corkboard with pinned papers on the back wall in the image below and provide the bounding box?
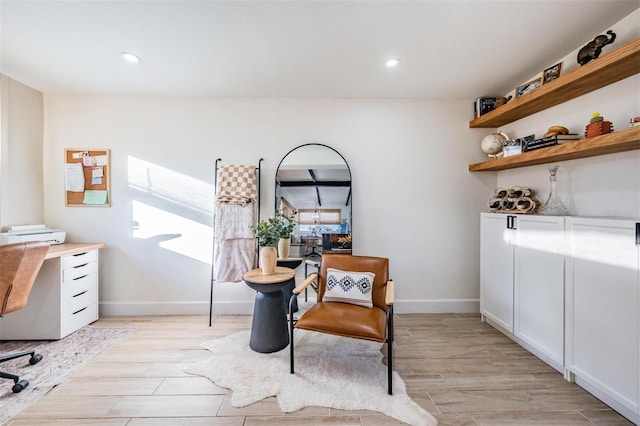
[64,148,111,207]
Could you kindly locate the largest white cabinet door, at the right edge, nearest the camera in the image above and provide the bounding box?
[566,218,640,415]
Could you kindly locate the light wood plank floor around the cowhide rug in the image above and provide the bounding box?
[2,314,630,426]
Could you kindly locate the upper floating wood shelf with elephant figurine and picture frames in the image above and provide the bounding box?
[469,38,640,128]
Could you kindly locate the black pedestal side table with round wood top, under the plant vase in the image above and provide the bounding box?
[242,266,295,353]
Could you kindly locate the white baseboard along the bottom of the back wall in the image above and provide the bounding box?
[100,300,480,317]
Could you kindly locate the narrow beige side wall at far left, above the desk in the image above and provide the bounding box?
[0,75,44,230]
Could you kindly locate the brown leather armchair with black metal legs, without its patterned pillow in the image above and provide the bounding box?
[289,252,394,395]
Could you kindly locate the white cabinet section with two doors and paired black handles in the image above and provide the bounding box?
[480,213,564,371]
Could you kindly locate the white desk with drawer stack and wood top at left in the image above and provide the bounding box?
[0,244,104,340]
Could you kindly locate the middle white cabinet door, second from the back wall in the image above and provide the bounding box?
[514,216,564,371]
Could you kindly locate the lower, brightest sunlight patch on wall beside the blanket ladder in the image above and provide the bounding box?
[132,201,213,264]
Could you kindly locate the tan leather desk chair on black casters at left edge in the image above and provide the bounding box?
[0,241,49,393]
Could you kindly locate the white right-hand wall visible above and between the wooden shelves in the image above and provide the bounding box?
[498,10,640,218]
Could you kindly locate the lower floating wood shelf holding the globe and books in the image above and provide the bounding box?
[469,126,640,172]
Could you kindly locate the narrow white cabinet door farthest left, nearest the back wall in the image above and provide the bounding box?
[480,213,513,333]
